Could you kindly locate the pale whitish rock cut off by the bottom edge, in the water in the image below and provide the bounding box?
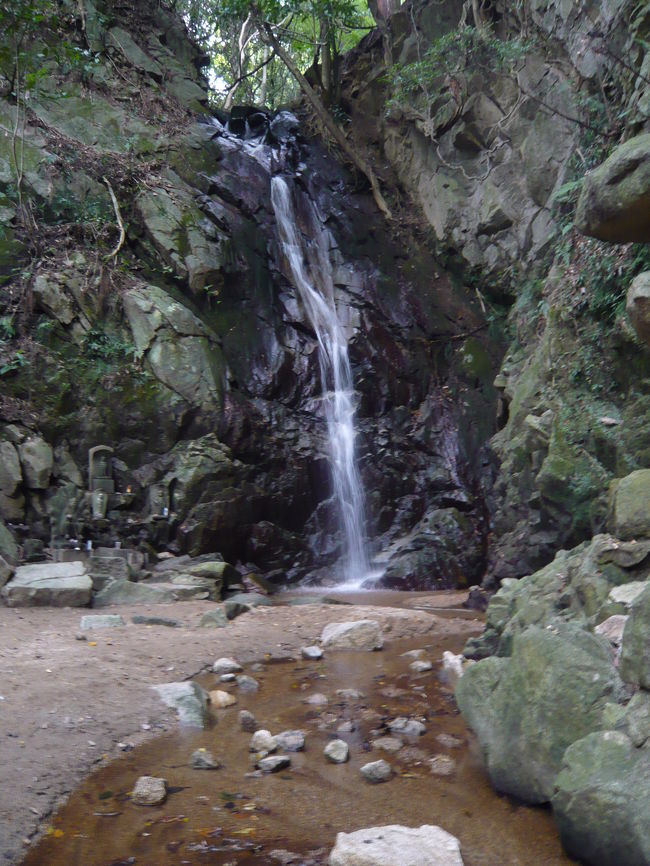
[329,824,463,866]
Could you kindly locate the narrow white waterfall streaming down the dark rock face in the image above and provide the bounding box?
[271,177,372,588]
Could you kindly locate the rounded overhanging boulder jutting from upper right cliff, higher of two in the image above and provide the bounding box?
[575,133,650,243]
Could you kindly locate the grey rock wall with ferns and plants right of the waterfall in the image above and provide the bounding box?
[344,0,650,588]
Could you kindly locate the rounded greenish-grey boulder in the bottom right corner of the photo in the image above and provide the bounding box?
[552,731,650,866]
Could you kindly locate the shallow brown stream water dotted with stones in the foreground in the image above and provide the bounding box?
[23,594,574,866]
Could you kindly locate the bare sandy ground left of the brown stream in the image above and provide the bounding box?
[0,593,481,864]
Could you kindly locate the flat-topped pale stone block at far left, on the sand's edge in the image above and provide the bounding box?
[0,562,92,607]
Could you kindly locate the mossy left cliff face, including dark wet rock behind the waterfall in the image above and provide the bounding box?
[0,2,498,587]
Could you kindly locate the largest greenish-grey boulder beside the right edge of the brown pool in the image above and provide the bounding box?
[456,623,622,803]
